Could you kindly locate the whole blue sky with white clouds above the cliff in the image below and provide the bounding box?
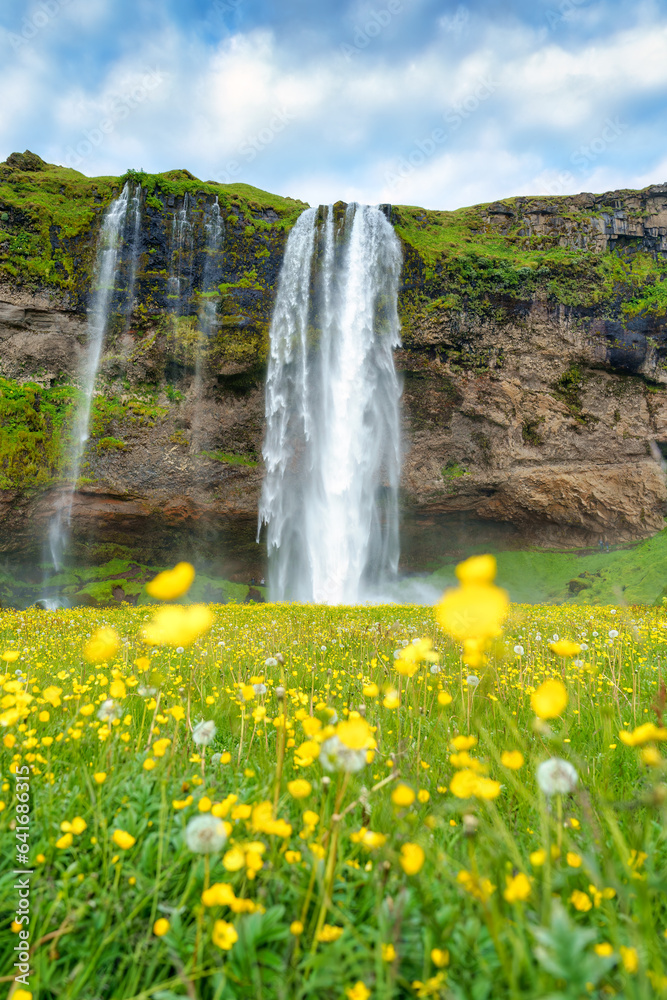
[0,0,667,208]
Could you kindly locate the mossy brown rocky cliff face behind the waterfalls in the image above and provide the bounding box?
[0,154,667,578]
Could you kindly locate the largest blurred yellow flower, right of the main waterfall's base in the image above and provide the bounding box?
[435,556,509,667]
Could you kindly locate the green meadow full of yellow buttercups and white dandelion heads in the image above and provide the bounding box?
[0,557,667,1000]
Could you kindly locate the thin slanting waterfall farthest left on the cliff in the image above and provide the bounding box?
[48,184,138,571]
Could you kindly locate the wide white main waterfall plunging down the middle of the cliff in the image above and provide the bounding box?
[259,205,401,604]
